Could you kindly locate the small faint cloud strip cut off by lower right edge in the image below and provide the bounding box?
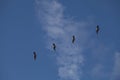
[111,52,120,80]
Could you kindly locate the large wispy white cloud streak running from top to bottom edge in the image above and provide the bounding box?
[36,0,91,80]
